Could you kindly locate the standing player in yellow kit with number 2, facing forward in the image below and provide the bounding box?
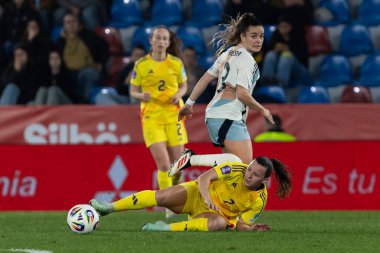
[130,26,187,216]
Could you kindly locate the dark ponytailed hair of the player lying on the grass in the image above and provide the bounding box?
[255,156,292,199]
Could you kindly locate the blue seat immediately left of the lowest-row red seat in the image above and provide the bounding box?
[297,86,330,104]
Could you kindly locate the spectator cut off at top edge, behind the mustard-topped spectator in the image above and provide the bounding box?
[54,0,101,31]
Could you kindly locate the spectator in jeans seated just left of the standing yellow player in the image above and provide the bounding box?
[95,45,146,105]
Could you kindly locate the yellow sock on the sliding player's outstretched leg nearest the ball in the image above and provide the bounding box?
[112,191,157,211]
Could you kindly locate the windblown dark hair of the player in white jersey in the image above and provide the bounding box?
[210,12,262,56]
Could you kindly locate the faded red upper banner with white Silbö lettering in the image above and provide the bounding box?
[0,104,380,145]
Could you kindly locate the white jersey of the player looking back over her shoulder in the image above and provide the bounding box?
[206,47,260,121]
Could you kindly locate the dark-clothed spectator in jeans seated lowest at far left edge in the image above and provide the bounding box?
[0,46,43,105]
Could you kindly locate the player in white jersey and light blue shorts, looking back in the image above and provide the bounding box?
[174,13,274,175]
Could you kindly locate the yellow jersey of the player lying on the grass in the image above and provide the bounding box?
[209,162,268,227]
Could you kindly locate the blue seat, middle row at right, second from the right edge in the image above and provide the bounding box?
[317,55,352,87]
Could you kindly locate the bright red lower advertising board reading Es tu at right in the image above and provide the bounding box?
[0,142,380,210]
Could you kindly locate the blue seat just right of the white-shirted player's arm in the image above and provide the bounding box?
[254,85,288,104]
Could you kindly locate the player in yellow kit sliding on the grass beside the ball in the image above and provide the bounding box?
[90,156,292,231]
